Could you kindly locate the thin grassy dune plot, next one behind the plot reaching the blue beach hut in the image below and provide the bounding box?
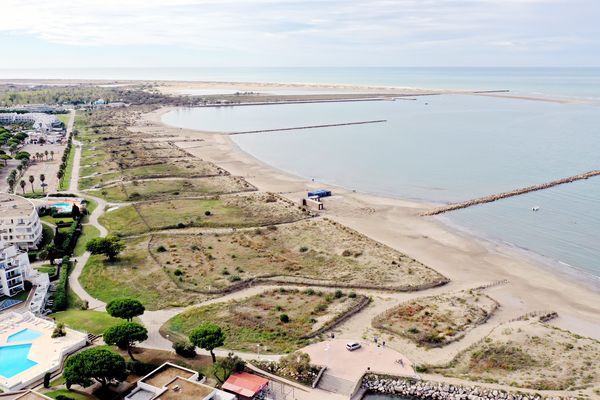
[89,176,254,202]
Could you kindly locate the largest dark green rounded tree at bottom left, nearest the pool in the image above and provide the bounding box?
[63,347,127,389]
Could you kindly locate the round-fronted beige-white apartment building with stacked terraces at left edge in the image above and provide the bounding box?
[0,193,42,250]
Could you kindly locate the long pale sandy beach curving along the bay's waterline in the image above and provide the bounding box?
[132,104,600,348]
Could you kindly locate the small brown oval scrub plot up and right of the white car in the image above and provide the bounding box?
[373,291,498,347]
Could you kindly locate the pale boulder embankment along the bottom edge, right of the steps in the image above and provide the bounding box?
[362,374,575,400]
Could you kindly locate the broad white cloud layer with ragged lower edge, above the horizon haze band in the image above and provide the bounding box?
[0,0,599,65]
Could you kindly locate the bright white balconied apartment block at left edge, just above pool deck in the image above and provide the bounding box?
[0,242,32,296]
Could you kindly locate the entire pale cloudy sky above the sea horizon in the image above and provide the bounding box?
[0,0,600,69]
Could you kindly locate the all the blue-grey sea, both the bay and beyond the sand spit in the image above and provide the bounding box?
[0,67,600,287]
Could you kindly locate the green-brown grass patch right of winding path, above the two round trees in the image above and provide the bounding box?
[79,237,208,310]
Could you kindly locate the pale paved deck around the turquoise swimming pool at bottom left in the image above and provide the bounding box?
[0,312,87,391]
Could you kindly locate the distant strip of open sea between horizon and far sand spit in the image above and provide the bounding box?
[0,66,600,99]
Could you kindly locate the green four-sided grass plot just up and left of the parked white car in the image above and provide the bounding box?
[161,289,362,353]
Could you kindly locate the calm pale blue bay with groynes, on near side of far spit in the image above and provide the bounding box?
[164,95,600,277]
